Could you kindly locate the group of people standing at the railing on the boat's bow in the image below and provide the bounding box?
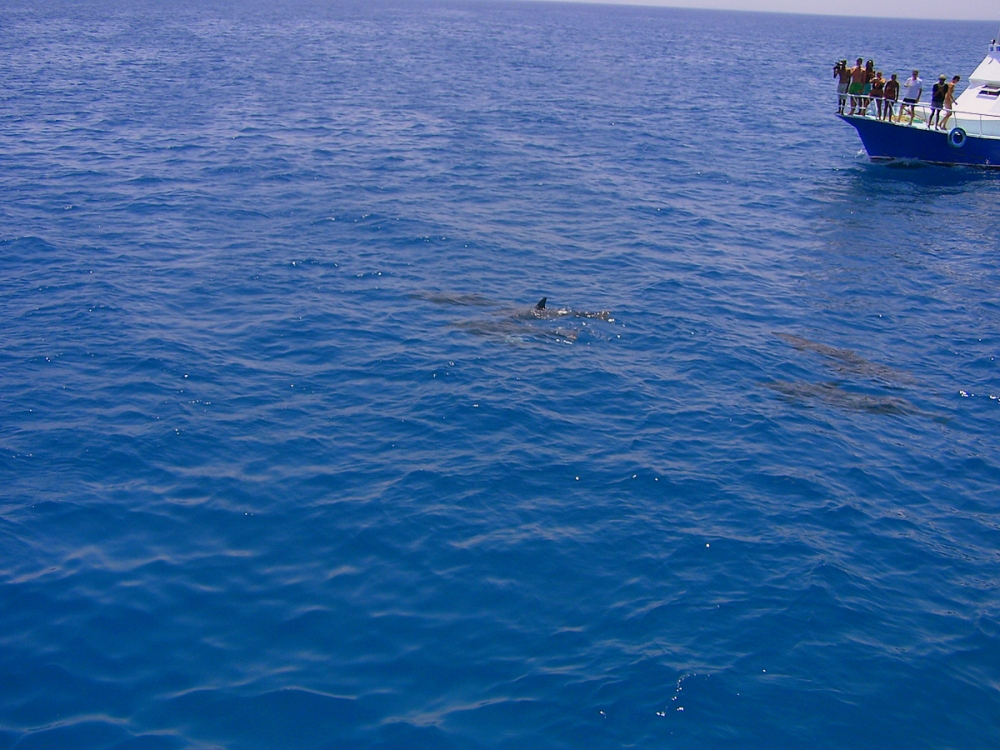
[833,57,962,130]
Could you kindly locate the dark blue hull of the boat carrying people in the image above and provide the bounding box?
[837,115,1000,169]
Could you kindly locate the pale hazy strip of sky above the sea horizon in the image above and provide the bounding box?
[540,0,1000,26]
